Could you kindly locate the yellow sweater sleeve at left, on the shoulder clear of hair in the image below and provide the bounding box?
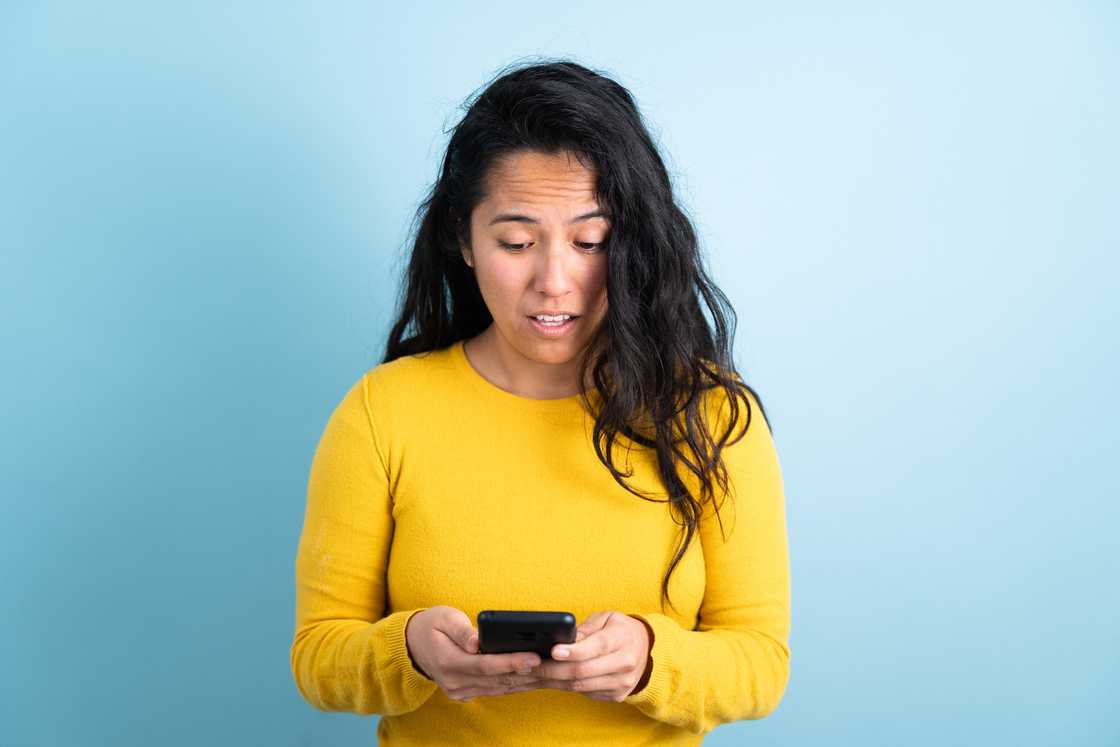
[291,373,438,716]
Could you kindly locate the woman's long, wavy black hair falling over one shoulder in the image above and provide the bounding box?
[383,59,769,608]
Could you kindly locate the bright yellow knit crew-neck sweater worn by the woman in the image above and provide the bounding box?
[291,343,791,747]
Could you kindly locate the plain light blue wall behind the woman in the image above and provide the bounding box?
[0,2,1120,746]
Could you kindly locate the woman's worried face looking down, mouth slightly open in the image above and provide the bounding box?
[463,151,610,364]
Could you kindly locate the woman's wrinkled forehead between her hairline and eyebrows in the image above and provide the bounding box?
[483,151,598,211]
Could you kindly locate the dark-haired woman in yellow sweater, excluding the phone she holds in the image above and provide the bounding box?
[291,62,791,746]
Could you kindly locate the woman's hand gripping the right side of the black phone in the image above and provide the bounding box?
[525,611,653,702]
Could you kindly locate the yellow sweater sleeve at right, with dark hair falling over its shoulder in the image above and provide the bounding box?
[625,394,791,734]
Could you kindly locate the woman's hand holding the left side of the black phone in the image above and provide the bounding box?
[404,605,541,701]
